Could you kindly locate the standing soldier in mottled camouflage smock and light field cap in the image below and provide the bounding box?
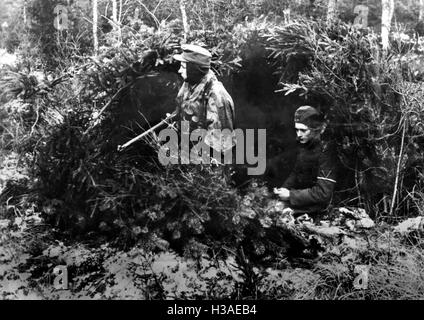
[173,44,235,156]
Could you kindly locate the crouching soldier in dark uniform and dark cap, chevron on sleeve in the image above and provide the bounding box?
[274,106,336,217]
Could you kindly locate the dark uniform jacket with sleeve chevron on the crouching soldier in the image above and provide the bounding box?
[283,140,336,214]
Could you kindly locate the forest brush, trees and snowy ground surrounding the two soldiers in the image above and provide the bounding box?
[0,0,424,299]
